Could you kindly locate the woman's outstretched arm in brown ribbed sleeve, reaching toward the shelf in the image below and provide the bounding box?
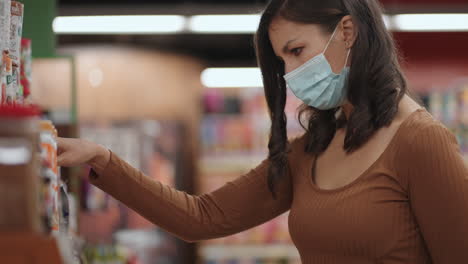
[59,139,298,242]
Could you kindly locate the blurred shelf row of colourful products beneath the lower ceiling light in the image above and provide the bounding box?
[201,88,303,156]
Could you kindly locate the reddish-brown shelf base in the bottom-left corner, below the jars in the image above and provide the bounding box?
[0,233,66,264]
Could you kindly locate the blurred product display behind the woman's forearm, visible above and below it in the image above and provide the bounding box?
[80,120,184,264]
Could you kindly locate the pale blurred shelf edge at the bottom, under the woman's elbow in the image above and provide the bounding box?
[200,244,300,260]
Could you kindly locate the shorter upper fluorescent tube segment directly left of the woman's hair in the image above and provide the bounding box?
[188,14,260,34]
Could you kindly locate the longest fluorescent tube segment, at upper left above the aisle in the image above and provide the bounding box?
[53,15,186,34]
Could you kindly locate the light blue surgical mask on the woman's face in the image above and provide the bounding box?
[284,27,350,110]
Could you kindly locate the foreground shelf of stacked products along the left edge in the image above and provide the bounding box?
[0,0,80,264]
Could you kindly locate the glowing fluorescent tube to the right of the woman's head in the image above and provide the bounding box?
[392,14,468,32]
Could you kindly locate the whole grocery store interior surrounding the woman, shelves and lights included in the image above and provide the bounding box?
[0,0,468,264]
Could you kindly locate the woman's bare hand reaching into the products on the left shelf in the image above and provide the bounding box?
[57,138,110,173]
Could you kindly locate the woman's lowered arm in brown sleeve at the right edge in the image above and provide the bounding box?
[406,124,468,264]
